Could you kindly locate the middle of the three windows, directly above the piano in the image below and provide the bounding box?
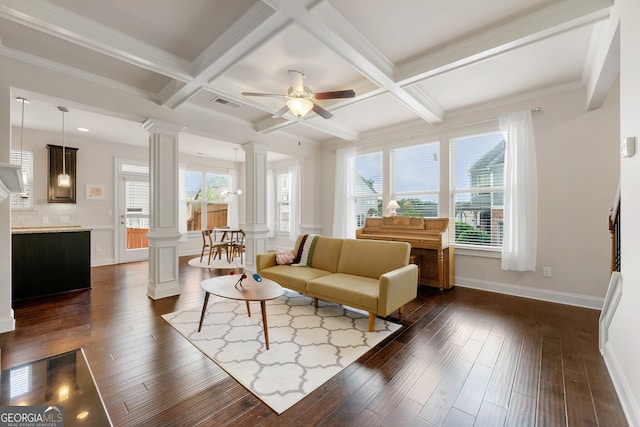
[391,142,440,217]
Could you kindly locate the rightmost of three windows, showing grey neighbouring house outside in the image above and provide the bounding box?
[450,132,505,247]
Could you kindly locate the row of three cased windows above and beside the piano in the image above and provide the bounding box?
[352,127,505,253]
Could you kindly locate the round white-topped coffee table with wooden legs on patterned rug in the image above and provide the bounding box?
[198,274,283,350]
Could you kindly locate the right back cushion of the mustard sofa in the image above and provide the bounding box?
[337,239,411,279]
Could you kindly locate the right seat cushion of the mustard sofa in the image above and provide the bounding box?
[307,273,379,313]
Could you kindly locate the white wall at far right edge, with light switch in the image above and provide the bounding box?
[605,0,640,426]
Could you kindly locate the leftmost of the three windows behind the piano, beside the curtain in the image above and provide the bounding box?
[354,151,383,227]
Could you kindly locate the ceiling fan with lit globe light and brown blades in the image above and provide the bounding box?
[242,70,356,119]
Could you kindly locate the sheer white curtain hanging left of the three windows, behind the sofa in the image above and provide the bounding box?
[333,147,356,239]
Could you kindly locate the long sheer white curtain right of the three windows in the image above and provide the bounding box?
[500,111,538,271]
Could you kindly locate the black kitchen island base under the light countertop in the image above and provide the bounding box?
[11,230,91,300]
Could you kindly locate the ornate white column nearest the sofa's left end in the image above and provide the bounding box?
[240,142,269,271]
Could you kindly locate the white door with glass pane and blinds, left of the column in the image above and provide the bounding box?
[117,174,149,262]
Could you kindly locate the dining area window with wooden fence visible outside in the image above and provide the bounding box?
[183,170,231,231]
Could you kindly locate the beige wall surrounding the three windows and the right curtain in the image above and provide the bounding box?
[323,86,619,308]
